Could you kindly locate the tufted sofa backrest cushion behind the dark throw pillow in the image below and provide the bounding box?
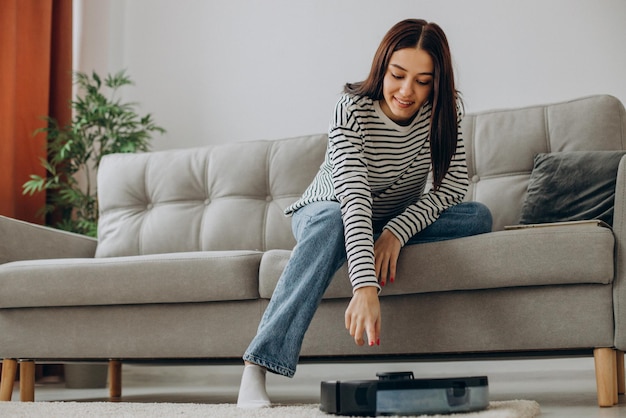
[461,95,626,230]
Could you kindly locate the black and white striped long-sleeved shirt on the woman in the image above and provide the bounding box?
[285,94,469,290]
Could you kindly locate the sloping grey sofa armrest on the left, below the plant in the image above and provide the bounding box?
[0,216,98,264]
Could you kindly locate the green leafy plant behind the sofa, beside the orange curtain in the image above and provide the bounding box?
[23,71,165,237]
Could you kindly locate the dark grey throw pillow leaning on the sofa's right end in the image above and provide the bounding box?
[519,151,626,225]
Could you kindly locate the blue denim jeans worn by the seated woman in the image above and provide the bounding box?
[243,202,491,377]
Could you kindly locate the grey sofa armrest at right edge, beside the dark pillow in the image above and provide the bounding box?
[613,156,626,351]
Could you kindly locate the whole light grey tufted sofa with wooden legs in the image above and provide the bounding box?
[0,95,626,406]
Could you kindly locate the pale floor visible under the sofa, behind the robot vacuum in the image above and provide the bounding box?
[8,358,626,418]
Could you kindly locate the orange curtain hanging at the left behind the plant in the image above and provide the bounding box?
[0,0,72,223]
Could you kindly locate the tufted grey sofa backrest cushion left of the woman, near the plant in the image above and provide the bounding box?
[96,135,327,257]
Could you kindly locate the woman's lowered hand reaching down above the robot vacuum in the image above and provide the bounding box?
[345,286,381,346]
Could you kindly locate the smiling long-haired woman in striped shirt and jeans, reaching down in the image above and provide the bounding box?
[238,19,491,408]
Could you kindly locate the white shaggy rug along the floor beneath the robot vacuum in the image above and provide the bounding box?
[0,400,541,418]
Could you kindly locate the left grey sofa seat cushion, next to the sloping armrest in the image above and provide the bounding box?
[0,251,262,308]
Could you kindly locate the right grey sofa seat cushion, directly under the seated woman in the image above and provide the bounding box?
[259,225,614,298]
